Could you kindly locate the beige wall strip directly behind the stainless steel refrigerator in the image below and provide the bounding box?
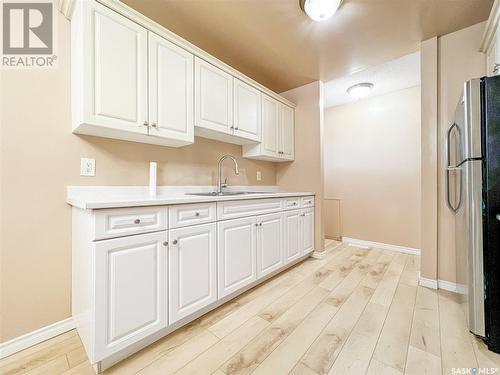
[437,22,486,281]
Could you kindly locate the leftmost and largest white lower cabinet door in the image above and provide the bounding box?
[91,231,167,363]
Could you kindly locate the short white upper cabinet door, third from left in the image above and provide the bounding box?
[195,58,233,134]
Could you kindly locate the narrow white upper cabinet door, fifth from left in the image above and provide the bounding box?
[261,95,280,158]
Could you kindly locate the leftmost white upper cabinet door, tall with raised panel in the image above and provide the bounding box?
[85,2,148,134]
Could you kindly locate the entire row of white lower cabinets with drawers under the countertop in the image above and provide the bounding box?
[72,196,314,371]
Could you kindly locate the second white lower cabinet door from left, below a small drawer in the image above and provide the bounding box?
[168,223,217,324]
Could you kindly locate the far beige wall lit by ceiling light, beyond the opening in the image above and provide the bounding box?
[324,87,420,248]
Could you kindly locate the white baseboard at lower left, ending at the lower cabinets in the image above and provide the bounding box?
[0,318,75,359]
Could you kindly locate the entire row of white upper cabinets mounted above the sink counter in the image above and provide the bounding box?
[71,0,294,151]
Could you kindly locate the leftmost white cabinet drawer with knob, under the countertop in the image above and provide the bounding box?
[94,207,167,240]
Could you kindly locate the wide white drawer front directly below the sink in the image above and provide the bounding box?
[217,199,283,220]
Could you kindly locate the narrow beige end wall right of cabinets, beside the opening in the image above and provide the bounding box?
[276,81,325,251]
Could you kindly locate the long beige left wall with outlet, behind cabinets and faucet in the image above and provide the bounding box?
[0,16,276,342]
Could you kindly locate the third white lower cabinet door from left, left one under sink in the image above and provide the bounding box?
[217,217,257,298]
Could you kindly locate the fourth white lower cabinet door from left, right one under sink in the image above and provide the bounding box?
[257,212,283,278]
